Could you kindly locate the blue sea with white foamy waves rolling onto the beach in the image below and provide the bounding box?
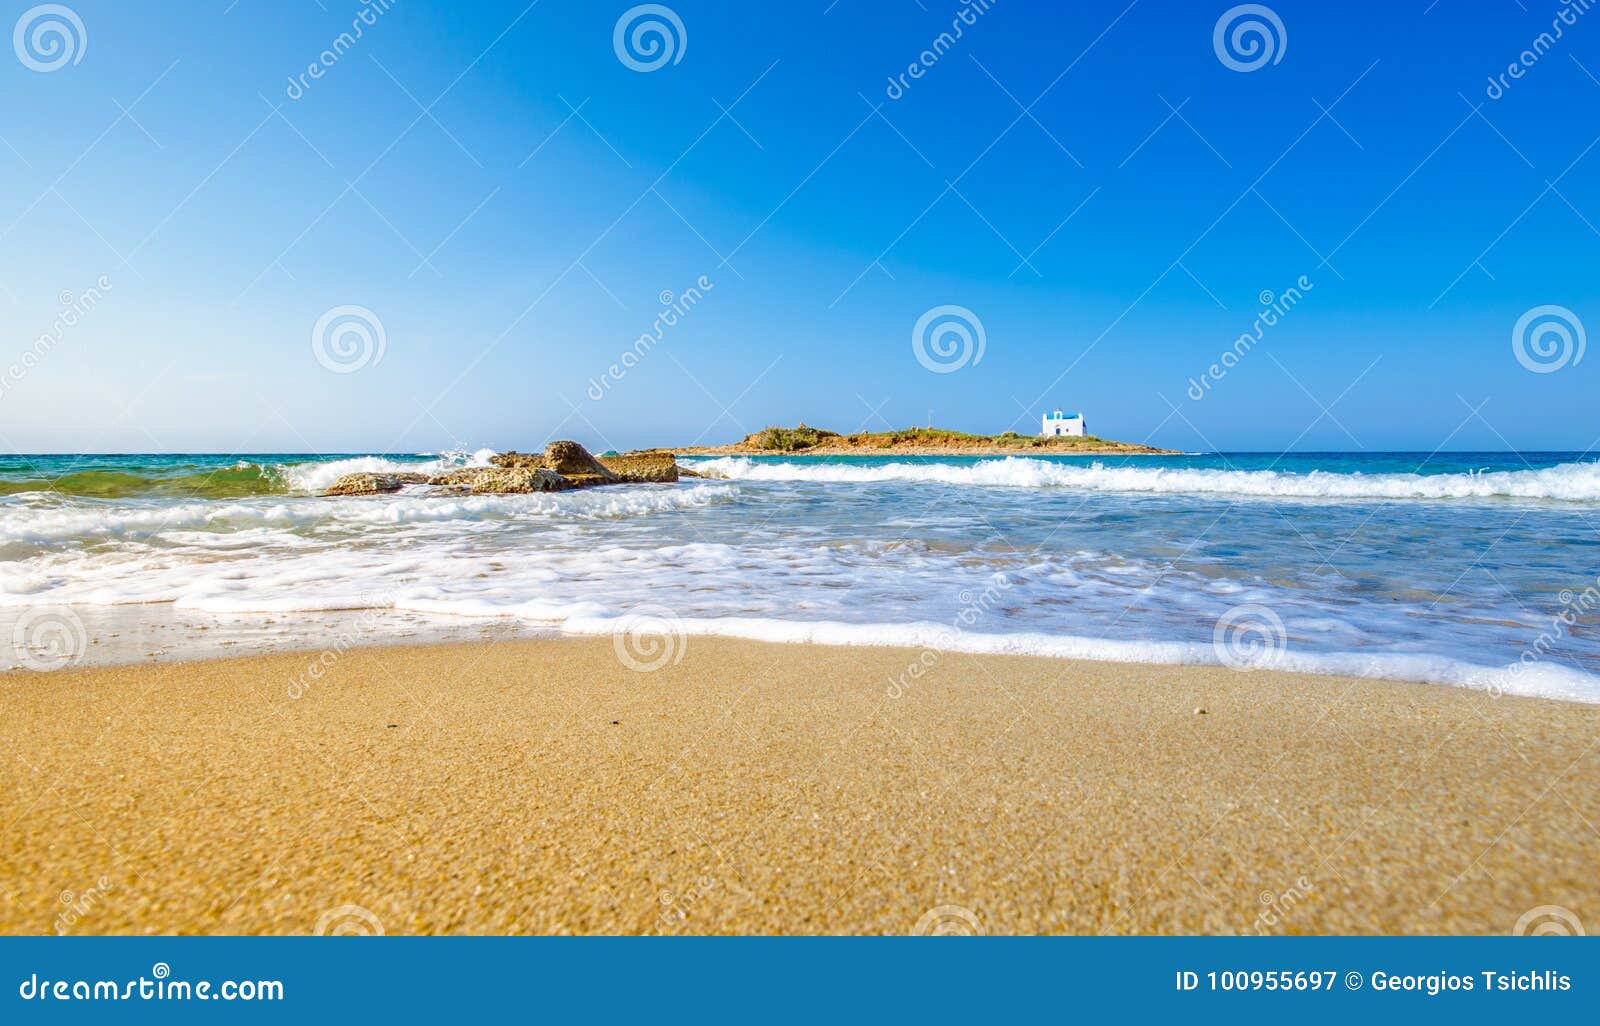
[0,450,1600,703]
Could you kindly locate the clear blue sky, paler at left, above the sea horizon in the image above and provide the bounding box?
[0,0,1600,453]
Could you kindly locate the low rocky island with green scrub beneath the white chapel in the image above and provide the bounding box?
[661,423,1178,456]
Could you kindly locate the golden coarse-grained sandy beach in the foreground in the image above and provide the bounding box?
[0,637,1600,933]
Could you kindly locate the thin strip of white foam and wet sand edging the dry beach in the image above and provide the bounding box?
[0,603,1600,707]
